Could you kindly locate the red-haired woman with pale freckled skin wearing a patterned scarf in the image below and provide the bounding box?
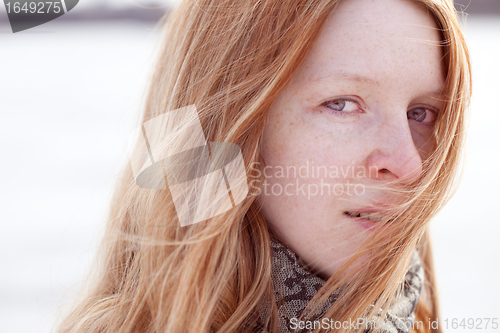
[59,0,471,332]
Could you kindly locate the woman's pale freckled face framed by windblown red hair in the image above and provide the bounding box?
[259,0,445,277]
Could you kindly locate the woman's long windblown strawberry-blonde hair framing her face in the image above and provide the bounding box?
[58,0,471,333]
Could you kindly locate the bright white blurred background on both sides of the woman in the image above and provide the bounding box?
[0,0,500,333]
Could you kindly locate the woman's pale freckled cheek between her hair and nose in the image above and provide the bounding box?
[259,110,352,223]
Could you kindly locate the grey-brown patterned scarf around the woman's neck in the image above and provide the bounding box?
[259,239,424,333]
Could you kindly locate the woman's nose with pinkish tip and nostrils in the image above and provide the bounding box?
[366,117,422,183]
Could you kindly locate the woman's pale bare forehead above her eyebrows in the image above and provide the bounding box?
[292,0,444,95]
